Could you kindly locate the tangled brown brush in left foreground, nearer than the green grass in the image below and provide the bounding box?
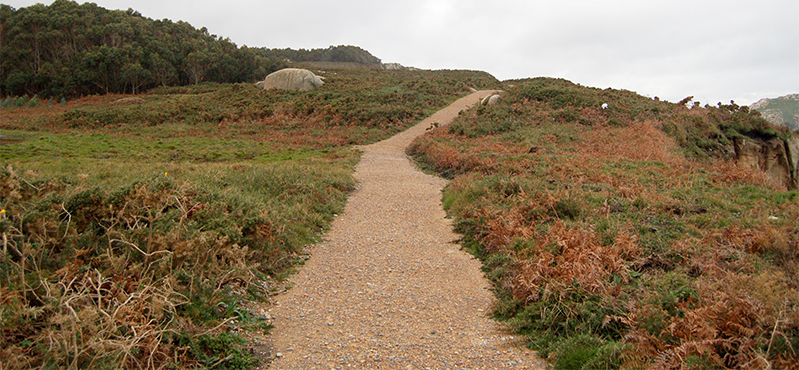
[0,166,352,369]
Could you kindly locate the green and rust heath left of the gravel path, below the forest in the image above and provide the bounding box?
[0,69,499,369]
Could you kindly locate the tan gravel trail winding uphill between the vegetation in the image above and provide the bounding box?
[269,91,544,369]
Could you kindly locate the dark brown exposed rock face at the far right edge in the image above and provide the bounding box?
[734,136,799,190]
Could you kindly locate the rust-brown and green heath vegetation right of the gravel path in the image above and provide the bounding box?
[409,78,799,369]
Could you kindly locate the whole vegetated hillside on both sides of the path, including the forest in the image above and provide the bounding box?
[0,0,799,370]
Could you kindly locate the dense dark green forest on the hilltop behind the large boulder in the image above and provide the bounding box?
[0,0,380,97]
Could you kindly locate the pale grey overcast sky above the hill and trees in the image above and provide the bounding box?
[6,0,799,105]
